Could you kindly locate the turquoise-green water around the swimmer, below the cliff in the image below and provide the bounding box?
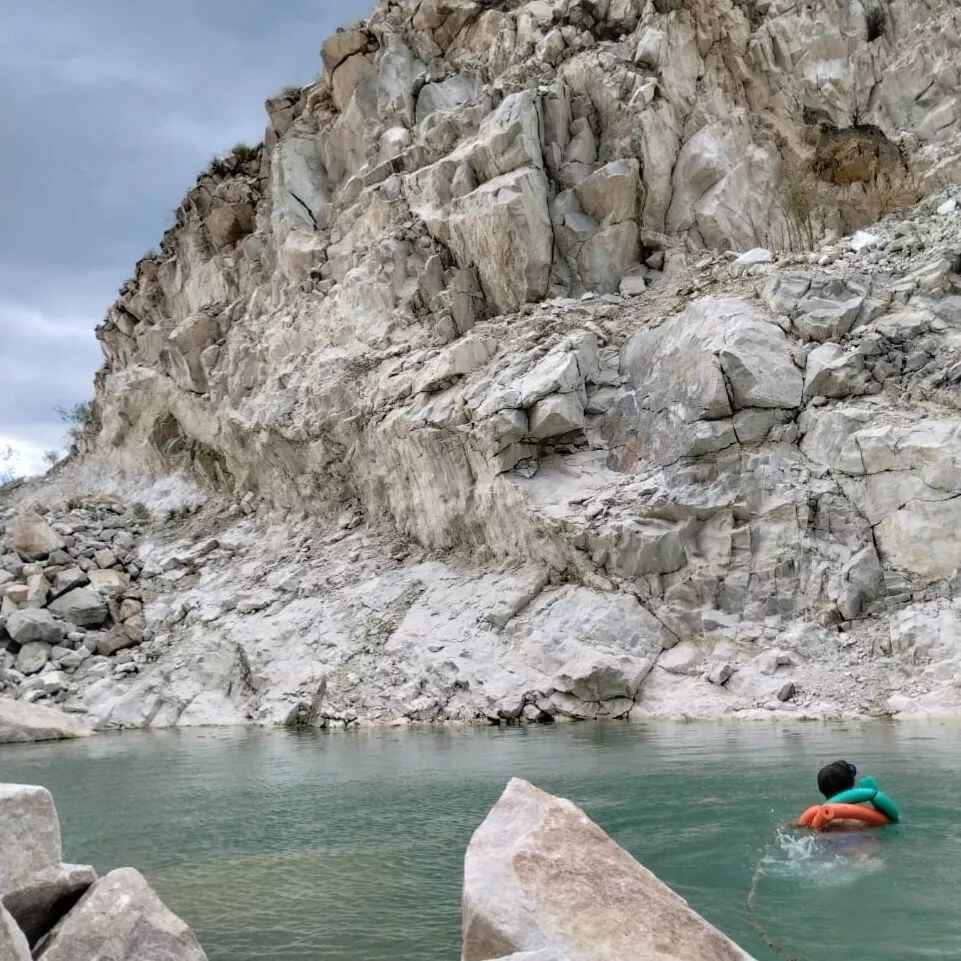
[0,723,961,961]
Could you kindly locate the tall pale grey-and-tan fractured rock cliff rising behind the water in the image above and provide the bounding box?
[5,0,961,726]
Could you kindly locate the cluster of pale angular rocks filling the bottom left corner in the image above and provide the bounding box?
[0,784,206,961]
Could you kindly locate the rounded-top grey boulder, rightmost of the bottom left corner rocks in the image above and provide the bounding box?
[43,868,207,961]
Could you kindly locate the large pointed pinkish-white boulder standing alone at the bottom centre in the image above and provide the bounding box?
[463,778,750,961]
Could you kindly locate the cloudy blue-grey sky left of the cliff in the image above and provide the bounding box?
[0,0,373,472]
